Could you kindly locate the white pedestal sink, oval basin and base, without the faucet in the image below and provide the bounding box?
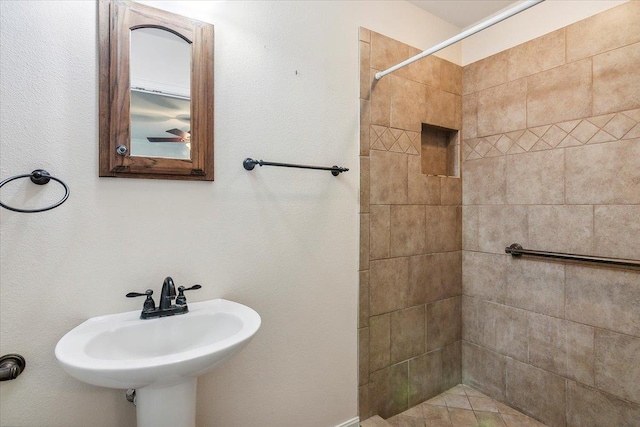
[55,299,261,427]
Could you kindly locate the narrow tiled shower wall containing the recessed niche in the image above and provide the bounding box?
[358,29,462,420]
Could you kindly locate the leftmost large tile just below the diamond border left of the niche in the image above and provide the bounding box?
[369,150,409,204]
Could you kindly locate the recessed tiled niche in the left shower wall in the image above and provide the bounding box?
[420,123,460,178]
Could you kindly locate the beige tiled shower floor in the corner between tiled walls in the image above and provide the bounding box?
[387,384,545,427]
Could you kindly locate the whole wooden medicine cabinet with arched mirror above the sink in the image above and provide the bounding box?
[99,0,213,181]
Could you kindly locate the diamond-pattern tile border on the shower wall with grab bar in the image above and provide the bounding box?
[464,109,640,160]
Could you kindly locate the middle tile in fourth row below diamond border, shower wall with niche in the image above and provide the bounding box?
[391,305,425,363]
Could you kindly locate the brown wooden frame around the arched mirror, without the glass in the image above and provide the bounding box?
[98,0,214,181]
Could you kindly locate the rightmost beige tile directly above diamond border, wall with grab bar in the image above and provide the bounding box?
[593,41,640,115]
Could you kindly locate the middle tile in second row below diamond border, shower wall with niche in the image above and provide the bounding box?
[389,205,425,257]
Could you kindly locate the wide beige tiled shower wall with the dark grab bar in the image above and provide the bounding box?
[462,1,640,427]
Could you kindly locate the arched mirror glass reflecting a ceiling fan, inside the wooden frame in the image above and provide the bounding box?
[130,28,191,160]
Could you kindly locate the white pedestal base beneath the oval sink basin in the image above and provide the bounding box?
[136,378,198,427]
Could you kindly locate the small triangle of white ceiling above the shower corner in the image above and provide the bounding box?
[409,0,518,28]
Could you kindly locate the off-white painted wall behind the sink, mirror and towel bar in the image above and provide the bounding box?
[0,1,460,427]
